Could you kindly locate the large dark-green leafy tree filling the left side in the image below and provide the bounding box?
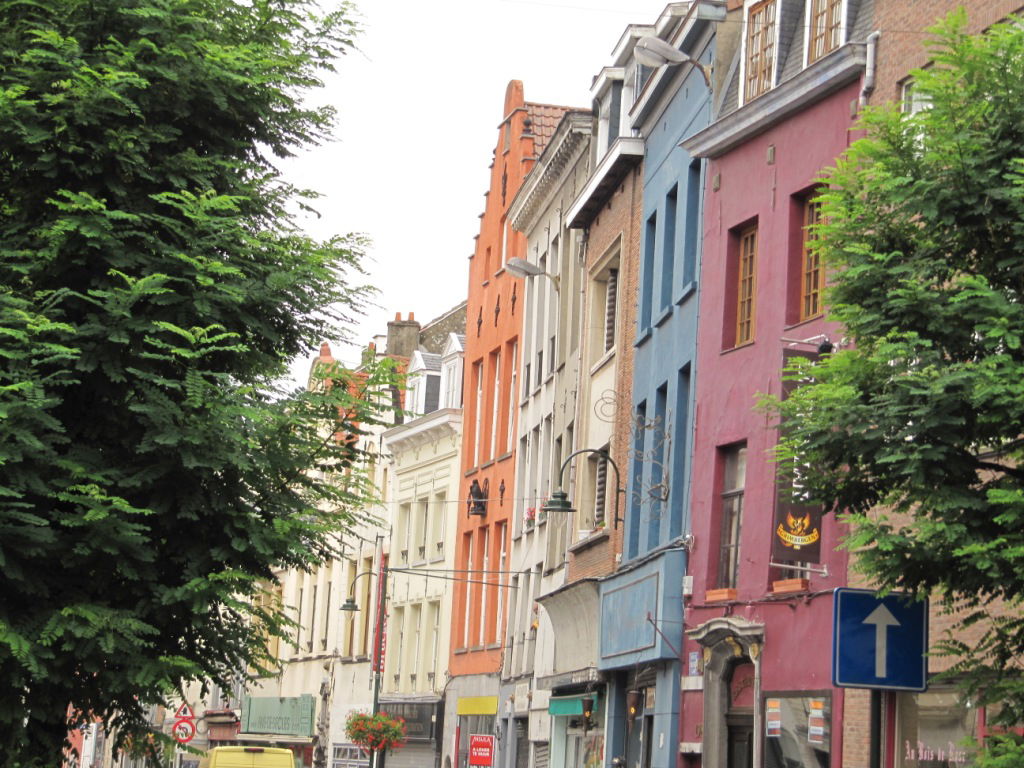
[0,0,391,766]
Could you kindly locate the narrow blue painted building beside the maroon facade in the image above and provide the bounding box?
[598,2,720,768]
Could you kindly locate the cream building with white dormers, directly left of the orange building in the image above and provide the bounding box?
[381,333,464,768]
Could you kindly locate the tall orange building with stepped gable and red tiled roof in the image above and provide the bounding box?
[444,80,566,766]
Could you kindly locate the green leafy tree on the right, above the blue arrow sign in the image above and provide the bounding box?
[778,12,1024,722]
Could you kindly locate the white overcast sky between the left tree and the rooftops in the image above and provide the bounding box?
[284,0,666,383]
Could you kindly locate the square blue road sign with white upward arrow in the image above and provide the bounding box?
[833,587,928,691]
